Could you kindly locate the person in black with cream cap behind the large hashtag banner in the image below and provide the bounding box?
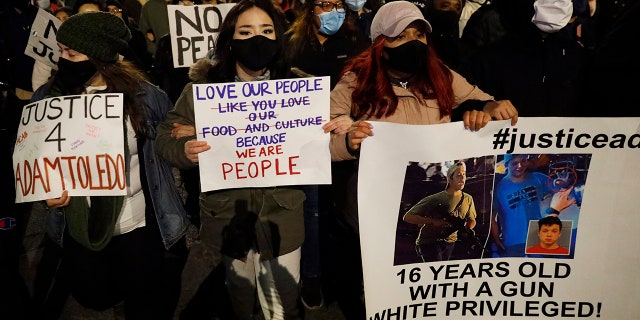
[458,0,589,117]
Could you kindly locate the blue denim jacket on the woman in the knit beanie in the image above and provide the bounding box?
[31,82,189,249]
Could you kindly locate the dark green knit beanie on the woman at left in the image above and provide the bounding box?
[56,12,131,62]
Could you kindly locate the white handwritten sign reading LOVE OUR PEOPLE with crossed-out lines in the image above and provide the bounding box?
[193,77,331,191]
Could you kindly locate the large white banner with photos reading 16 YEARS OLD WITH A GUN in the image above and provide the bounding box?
[358,118,640,320]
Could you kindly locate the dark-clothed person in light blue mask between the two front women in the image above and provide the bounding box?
[285,0,370,312]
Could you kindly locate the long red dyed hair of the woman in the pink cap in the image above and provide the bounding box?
[343,36,455,119]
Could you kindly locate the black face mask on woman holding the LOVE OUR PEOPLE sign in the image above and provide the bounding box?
[231,36,280,71]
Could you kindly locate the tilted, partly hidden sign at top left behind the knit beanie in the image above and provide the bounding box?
[24,9,62,69]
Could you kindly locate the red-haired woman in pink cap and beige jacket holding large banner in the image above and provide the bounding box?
[325,1,518,316]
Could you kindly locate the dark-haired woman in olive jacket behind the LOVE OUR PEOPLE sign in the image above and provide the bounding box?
[156,0,322,319]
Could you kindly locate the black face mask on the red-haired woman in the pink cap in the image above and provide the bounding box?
[383,40,427,74]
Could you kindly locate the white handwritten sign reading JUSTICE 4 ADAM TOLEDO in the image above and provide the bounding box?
[13,93,126,202]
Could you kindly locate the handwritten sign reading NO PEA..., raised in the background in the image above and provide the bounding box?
[167,3,235,68]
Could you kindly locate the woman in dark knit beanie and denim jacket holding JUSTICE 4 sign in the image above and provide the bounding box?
[32,12,189,319]
